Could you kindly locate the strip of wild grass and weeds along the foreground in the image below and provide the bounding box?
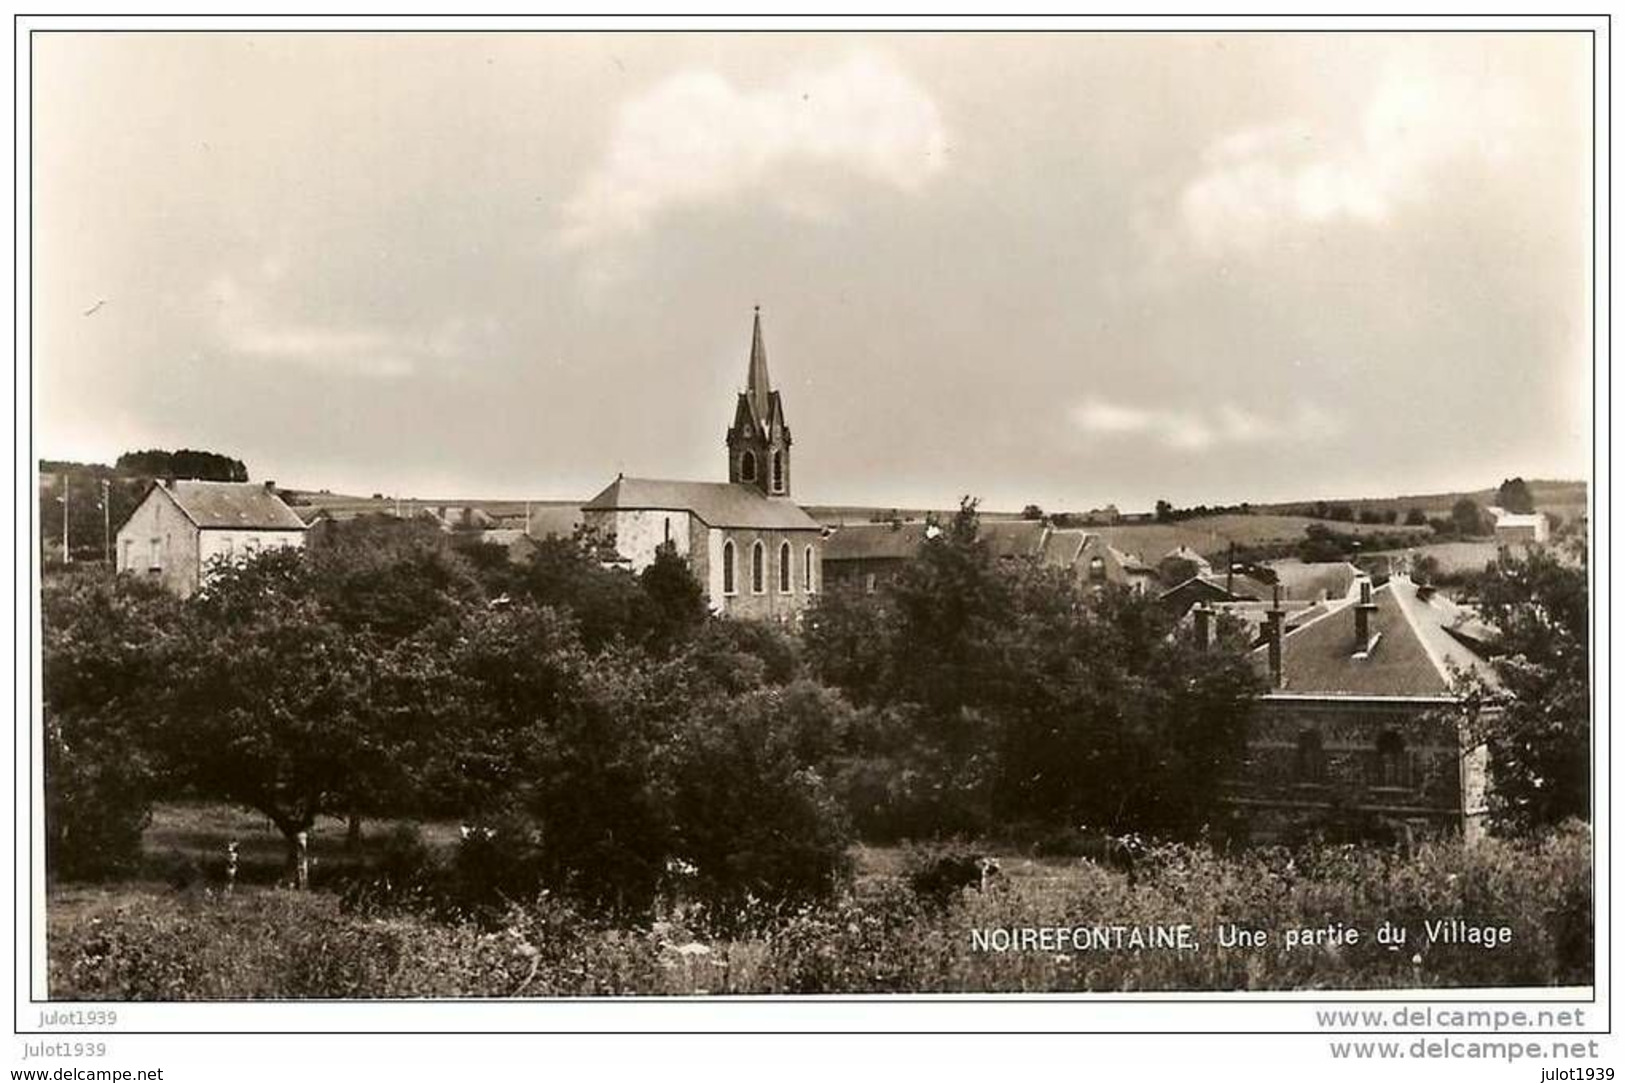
[47,796,1593,1000]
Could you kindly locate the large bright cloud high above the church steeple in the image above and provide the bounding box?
[561,54,947,247]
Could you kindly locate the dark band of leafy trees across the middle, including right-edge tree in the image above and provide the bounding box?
[42,501,1589,912]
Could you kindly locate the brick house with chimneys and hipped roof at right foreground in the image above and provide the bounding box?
[1222,576,1493,842]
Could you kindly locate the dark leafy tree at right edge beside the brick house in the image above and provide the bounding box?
[1459,543,1591,831]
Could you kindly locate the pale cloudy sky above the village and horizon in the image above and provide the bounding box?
[33,34,1591,511]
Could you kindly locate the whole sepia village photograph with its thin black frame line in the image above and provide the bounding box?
[15,20,1609,1060]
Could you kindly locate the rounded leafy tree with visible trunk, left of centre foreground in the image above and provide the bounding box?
[163,550,452,886]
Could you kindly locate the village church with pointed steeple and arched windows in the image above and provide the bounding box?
[582,309,824,620]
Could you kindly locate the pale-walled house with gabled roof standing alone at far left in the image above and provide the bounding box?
[115,480,306,597]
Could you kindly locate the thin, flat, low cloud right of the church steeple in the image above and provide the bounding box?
[1071,398,1342,450]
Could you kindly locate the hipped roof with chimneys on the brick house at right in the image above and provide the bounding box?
[1253,576,1490,696]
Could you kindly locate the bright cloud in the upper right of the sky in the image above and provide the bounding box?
[1178,70,1515,254]
